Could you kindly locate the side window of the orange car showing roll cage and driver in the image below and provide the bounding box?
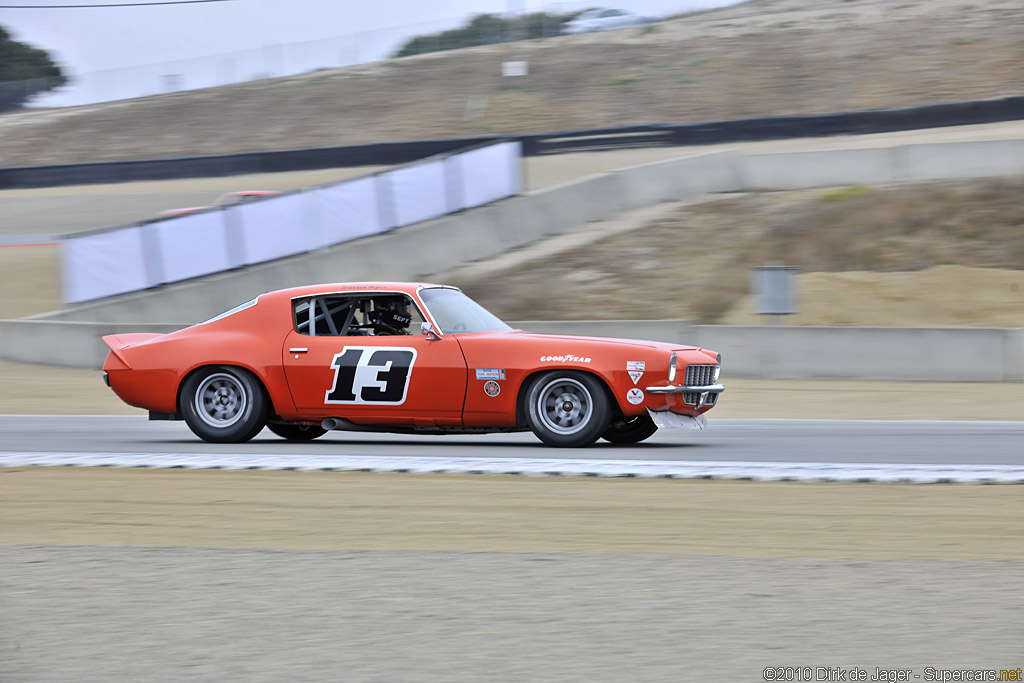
[292,294,423,337]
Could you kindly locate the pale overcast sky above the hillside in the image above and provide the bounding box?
[0,0,738,105]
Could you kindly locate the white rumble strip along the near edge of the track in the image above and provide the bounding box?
[0,452,1024,483]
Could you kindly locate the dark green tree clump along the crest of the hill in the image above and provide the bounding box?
[394,12,579,57]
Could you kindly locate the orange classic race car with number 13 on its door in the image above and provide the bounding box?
[103,283,724,446]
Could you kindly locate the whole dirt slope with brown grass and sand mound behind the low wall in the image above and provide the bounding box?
[447,179,1024,327]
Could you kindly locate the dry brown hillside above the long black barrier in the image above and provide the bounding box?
[0,0,1024,166]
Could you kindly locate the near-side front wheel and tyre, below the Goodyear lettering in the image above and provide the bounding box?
[526,370,611,449]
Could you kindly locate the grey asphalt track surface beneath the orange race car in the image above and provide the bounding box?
[8,416,1024,467]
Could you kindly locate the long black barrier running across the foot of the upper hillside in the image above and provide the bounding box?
[0,95,1024,189]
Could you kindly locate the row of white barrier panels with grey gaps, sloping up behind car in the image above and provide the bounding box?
[61,142,521,303]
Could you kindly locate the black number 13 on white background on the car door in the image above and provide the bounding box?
[324,346,416,405]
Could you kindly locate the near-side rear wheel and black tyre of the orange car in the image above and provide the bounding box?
[181,366,267,443]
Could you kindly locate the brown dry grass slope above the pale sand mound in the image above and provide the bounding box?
[453,180,1024,325]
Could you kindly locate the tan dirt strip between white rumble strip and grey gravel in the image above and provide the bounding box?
[8,468,1024,559]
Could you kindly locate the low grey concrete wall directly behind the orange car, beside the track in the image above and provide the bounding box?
[0,319,1024,382]
